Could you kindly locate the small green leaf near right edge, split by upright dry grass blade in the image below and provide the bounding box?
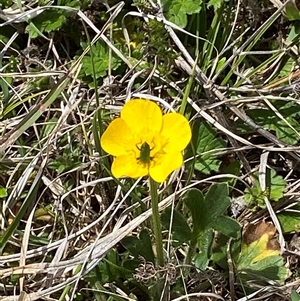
[245,169,286,208]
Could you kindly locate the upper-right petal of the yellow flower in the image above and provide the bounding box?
[161,113,192,153]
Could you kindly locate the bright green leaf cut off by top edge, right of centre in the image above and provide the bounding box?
[162,0,202,28]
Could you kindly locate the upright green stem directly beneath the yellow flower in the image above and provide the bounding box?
[150,178,164,266]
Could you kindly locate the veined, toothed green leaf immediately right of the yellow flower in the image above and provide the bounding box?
[187,120,226,174]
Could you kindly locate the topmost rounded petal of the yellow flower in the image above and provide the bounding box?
[121,99,162,142]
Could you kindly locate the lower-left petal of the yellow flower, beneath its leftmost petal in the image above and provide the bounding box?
[111,152,148,178]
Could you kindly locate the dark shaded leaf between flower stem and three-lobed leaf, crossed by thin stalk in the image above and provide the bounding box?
[161,207,192,246]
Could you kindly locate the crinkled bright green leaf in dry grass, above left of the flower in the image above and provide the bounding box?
[80,41,121,79]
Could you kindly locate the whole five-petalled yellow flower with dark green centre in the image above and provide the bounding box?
[101,99,192,183]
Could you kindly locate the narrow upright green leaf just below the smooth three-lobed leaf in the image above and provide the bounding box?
[193,229,214,271]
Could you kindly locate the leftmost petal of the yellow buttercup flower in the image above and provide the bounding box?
[100,118,135,156]
